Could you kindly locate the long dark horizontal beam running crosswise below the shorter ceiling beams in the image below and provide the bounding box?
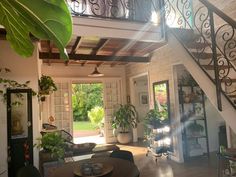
[39,52,150,63]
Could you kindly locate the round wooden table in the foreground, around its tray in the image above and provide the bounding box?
[49,157,139,177]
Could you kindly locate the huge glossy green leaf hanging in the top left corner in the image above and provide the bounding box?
[0,0,72,59]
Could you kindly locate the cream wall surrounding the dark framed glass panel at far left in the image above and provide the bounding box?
[0,41,40,177]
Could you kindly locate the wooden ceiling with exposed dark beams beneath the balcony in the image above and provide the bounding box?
[39,36,165,67]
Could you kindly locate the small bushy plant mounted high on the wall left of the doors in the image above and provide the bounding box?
[38,75,57,101]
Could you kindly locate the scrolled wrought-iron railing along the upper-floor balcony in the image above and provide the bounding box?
[67,0,160,22]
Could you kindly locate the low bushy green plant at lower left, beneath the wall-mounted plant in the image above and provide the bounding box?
[35,132,67,161]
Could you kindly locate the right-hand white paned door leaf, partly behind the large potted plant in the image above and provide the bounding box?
[103,79,122,143]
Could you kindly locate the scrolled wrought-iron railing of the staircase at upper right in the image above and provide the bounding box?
[164,0,236,111]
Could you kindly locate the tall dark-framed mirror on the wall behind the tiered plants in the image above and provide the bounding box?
[153,80,170,123]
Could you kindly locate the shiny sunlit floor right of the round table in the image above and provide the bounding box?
[120,145,217,177]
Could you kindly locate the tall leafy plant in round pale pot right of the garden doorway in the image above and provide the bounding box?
[112,104,139,144]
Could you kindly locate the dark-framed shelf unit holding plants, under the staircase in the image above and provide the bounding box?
[178,83,209,160]
